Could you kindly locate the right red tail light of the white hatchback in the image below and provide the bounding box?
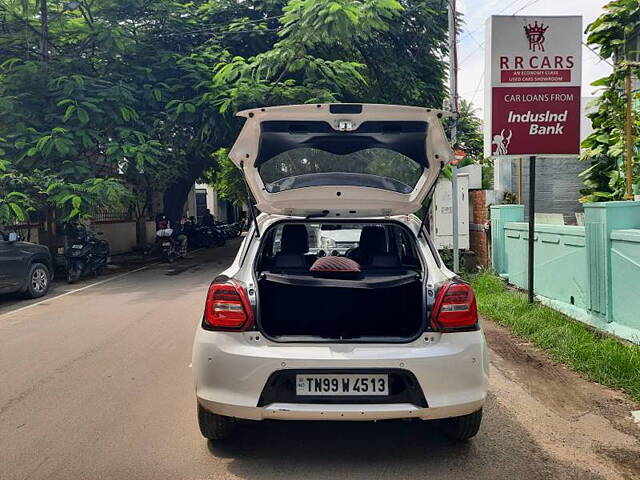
[431,281,478,331]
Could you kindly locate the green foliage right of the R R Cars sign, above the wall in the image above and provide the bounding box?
[580,0,640,202]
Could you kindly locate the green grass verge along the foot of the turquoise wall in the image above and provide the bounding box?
[468,273,640,401]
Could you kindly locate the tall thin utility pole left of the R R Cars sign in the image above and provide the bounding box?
[448,0,460,273]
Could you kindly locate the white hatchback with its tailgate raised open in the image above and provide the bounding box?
[193,104,489,440]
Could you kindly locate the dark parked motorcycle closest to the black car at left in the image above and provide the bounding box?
[64,224,110,283]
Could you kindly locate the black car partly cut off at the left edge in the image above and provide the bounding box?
[0,231,53,298]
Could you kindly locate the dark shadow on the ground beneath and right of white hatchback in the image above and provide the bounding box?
[199,401,599,480]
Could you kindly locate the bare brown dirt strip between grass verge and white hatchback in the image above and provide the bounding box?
[483,319,640,479]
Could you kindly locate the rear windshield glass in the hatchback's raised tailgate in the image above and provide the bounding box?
[259,147,423,193]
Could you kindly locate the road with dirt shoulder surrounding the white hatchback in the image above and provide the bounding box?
[0,241,640,480]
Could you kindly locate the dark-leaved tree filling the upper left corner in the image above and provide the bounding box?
[0,0,225,232]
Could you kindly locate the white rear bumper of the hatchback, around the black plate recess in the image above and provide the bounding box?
[193,329,489,420]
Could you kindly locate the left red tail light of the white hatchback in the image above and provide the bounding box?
[204,279,253,330]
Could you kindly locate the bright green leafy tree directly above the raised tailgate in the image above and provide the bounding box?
[202,0,447,208]
